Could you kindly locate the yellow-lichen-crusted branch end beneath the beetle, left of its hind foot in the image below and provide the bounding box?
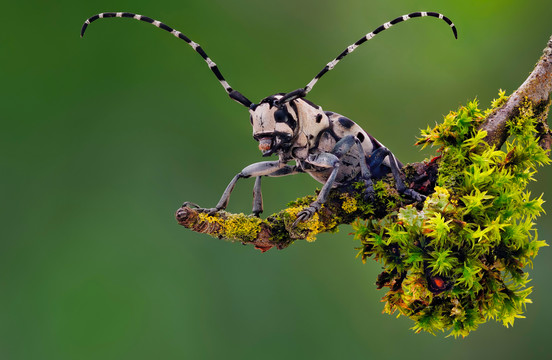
[176,177,422,252]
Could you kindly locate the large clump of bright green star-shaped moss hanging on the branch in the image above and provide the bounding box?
[354,91,550,336]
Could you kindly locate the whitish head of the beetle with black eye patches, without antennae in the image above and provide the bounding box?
[249,94,297,156]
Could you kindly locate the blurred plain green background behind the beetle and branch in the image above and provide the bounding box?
[0,0,552,359]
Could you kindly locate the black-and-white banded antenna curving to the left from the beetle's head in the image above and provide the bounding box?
[81,12,252,107]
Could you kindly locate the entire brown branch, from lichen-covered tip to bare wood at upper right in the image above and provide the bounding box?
[176,37,552,252]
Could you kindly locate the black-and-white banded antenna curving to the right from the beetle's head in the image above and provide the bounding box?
[280,11,458,103]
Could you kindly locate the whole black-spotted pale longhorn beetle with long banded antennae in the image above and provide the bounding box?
[81,11,458,226]
